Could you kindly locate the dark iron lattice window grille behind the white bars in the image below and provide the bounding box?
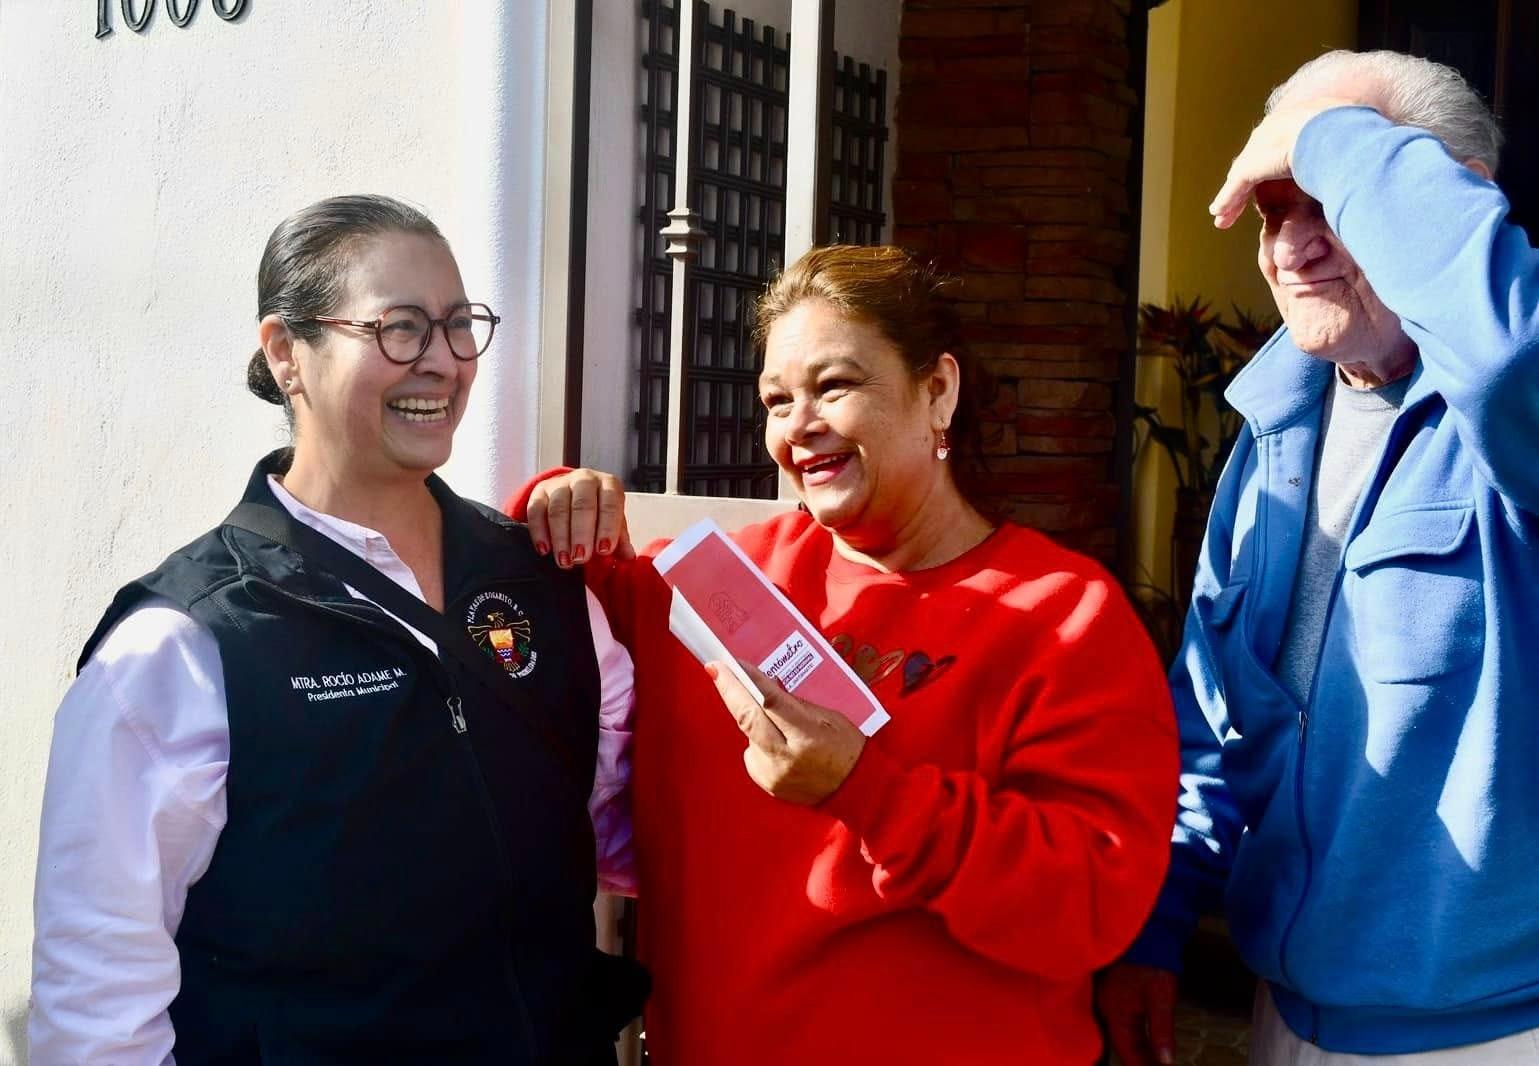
[629,0,888,498]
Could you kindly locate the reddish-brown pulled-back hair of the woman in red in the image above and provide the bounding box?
[754,245,993,514]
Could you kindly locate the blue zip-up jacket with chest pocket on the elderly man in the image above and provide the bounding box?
[1128,108,1539,1054]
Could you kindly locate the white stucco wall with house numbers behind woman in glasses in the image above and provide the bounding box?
[0,0,545,1063]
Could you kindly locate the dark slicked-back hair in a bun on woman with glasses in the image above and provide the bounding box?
[246,195,443,408]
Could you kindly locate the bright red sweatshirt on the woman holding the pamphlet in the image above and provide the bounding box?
[510,498,1177,1066]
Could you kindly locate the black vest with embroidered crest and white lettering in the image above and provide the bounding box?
[82,452,616,1066]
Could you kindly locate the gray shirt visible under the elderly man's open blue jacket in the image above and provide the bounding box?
[1276,374,1411,706]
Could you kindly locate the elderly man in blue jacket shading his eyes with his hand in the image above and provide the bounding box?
[1100,52,1539,1066]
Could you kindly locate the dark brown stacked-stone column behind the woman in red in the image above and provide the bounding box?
[893,0,1137,563]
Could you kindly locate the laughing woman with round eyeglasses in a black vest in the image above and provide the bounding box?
[29,197,645,1066]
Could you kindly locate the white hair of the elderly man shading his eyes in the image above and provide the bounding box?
[1267,49,1502,174]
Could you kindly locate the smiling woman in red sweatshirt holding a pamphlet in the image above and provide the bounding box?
[514,246,1177,1066]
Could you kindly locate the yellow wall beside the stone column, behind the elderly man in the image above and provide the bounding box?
[1134,0,1357,599]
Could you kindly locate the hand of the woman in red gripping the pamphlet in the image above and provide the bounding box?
[705,663,865,806]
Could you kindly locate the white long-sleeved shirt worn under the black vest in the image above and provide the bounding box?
[28,478,634,1066]
